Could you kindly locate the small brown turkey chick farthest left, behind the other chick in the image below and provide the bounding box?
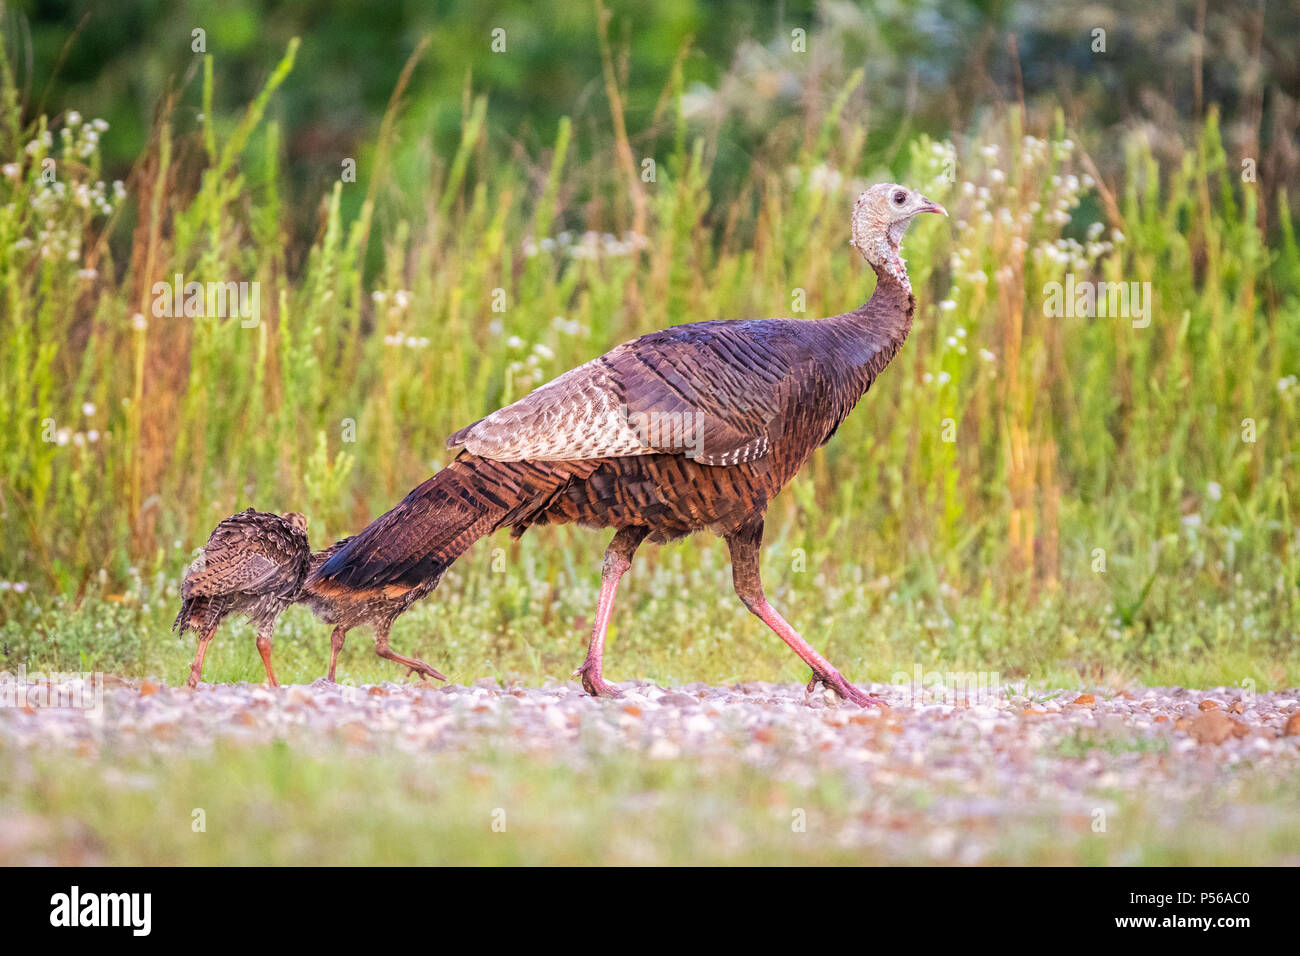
[172,509,311,687]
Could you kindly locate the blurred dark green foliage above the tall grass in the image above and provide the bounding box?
[17,0,1300,251]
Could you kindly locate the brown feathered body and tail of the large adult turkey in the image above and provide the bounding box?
[308,284,913,590]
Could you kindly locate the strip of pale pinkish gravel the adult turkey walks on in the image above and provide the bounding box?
[0,678,1300,862]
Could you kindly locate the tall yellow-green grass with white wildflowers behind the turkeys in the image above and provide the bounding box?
[0,31,1300,680]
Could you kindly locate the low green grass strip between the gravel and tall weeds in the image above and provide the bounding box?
[0,546,1300,691]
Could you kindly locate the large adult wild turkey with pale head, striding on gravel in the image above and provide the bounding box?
[314,183,946,706]
